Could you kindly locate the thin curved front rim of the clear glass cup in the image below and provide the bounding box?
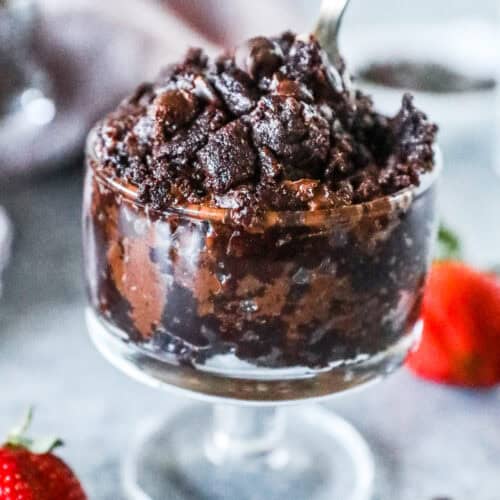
[85,125,443,226]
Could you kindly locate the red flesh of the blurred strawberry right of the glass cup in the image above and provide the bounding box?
[407,261,500,387]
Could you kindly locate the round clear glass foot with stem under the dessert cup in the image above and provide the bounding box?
[123,405,374,500]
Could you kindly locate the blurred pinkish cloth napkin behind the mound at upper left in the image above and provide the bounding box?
[0,0,319,178]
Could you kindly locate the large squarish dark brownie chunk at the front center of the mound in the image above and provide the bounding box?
[197,120,256,194]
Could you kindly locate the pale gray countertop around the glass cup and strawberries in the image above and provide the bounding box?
[0,154,500,500]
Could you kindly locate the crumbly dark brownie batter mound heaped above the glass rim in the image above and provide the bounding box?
[96,33,436,226]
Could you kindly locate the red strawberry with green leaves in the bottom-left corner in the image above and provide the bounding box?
[0,412,87,500]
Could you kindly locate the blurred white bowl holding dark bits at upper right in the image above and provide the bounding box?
[346,20,498,164]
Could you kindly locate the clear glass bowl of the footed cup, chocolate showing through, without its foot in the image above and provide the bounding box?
[84,137,439,402]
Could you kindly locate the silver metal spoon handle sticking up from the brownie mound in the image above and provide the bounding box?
[314,0,350,70]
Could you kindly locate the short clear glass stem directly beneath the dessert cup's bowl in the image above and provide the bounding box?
[206,404,285,463]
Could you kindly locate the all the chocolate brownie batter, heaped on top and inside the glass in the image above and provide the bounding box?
[85,33,436,380]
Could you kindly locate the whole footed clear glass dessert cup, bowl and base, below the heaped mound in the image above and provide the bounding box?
[84,135,439,500]
